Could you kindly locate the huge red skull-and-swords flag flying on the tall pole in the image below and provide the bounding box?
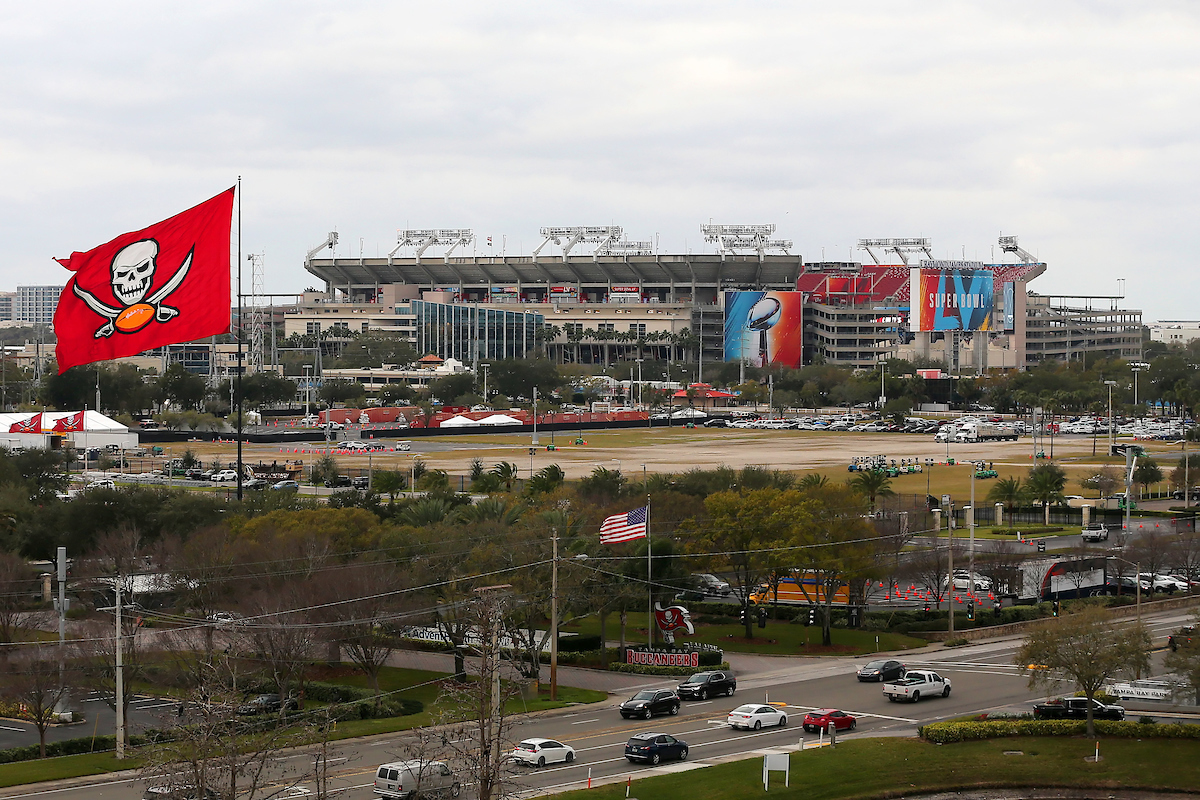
[54,188,234,374]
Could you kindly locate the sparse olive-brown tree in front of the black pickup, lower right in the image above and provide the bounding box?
[1013,606,1150,736]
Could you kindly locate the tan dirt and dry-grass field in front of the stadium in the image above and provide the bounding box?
[164,428,1180,494]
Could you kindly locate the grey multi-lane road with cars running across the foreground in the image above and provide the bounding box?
[0,612,1196,800]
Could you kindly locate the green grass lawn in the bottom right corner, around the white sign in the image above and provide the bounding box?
[557,738,1200,800]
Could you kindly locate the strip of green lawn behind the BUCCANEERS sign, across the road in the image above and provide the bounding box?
[563,609,929,656]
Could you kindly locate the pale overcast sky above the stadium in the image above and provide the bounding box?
[0,0,1200,321]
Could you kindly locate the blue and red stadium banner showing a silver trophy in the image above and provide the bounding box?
[725,291,804,367]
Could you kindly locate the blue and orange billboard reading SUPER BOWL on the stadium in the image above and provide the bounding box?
[908,266,995,331]
